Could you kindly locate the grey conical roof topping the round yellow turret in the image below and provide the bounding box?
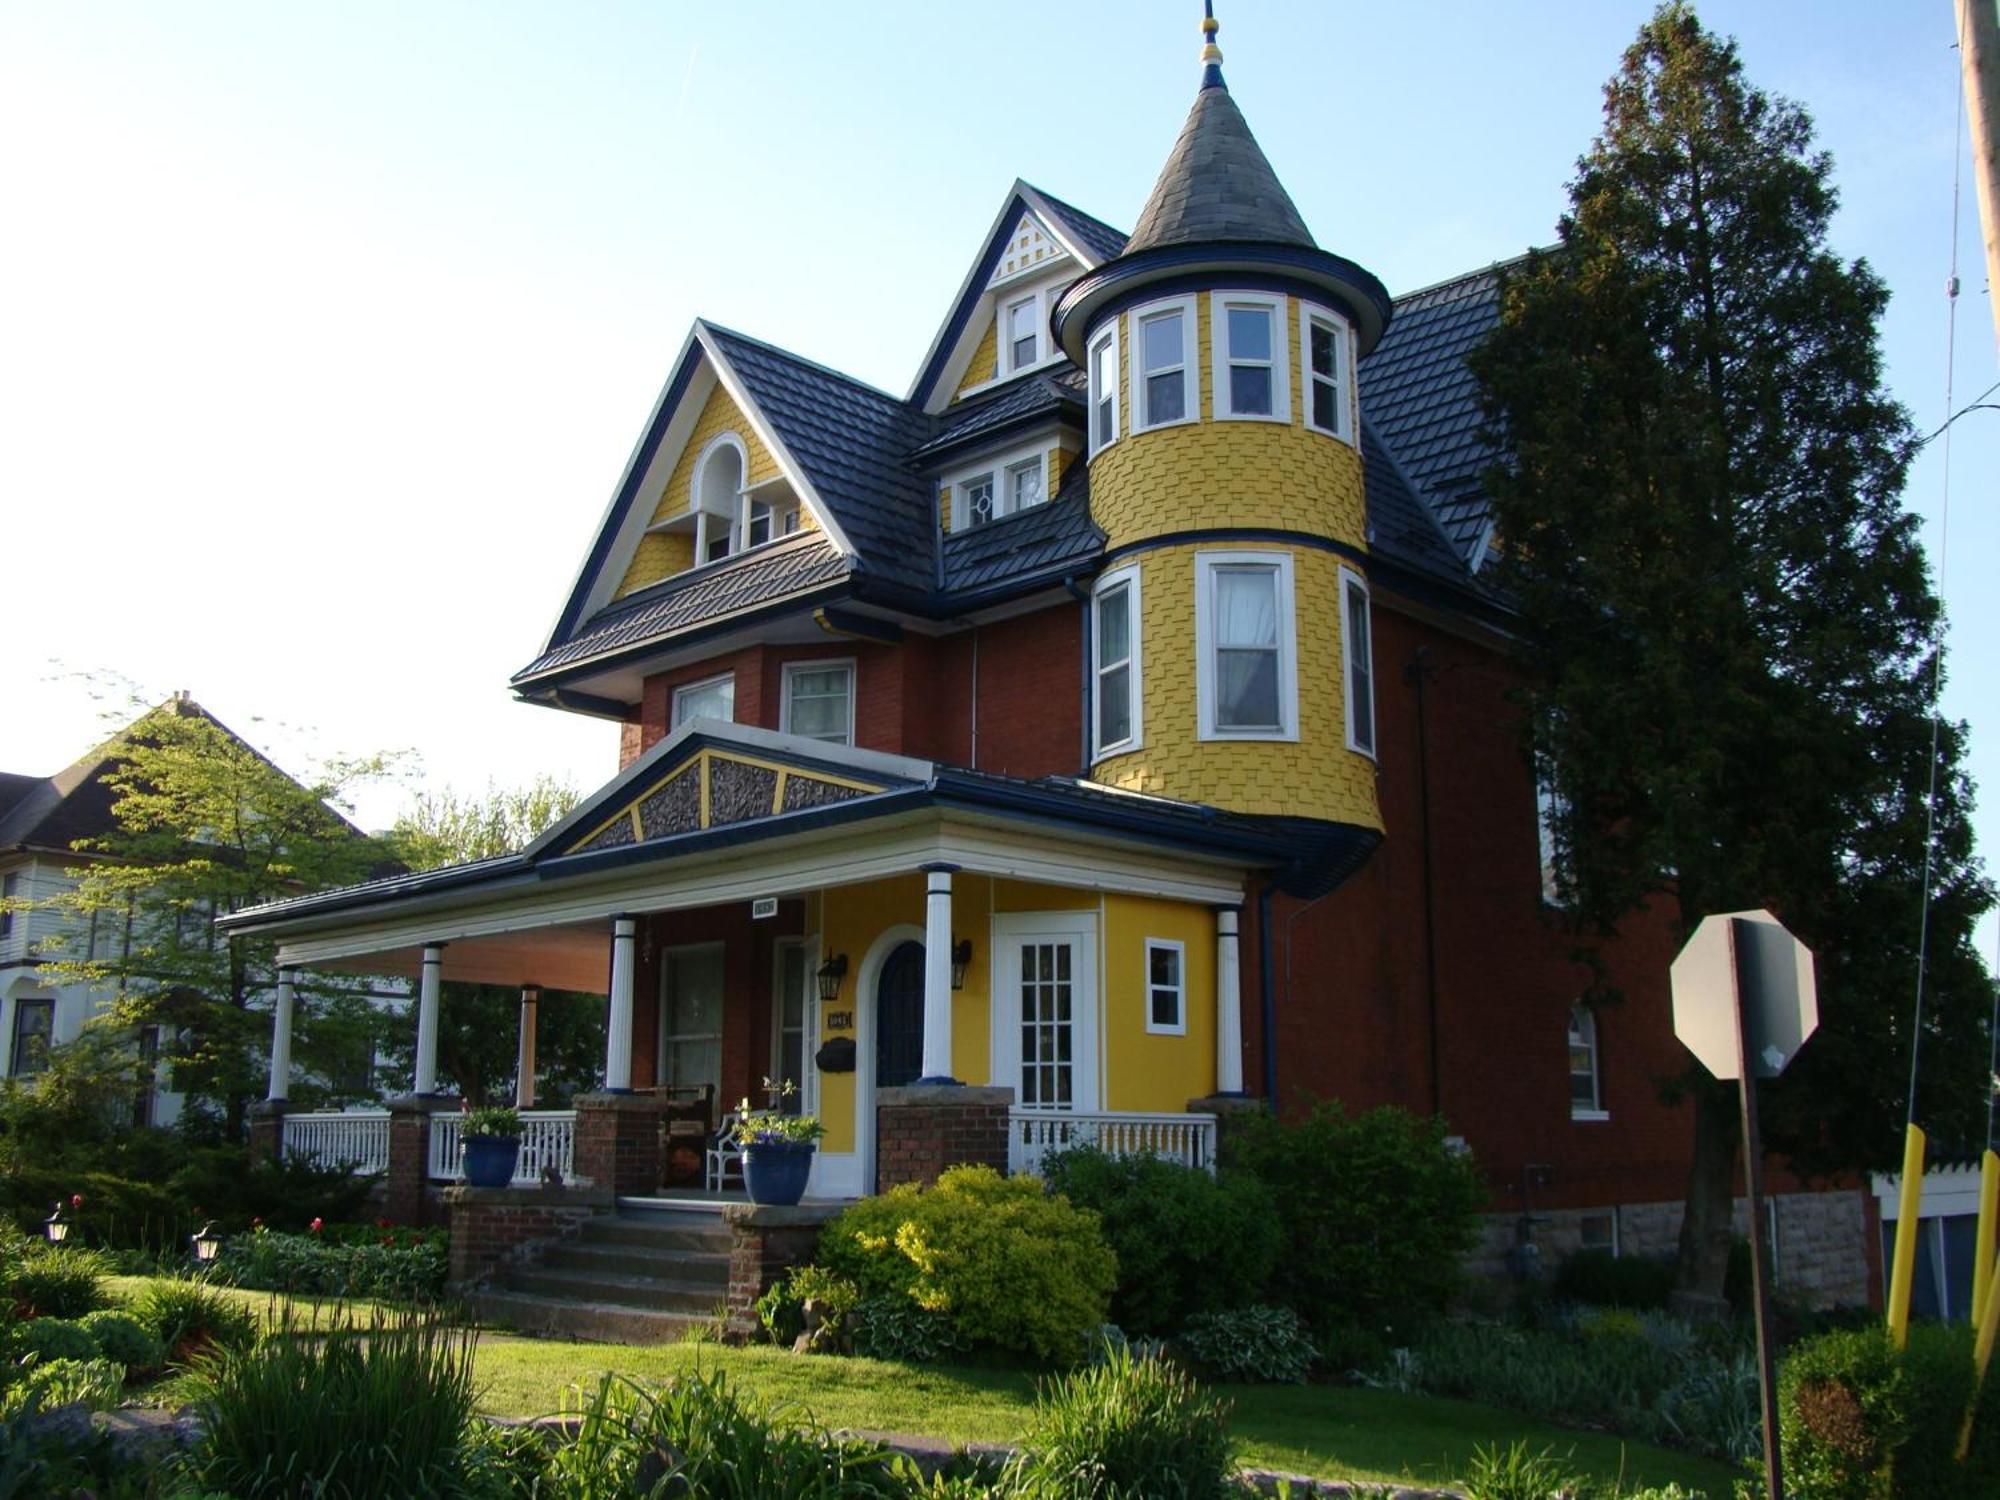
[1124,86,1316,254]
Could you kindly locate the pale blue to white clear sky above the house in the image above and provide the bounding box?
[0,0,2000,954]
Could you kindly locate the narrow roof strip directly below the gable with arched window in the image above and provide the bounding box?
[514,532,852,682]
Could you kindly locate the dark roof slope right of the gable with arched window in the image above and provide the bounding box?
[704,324,938,588]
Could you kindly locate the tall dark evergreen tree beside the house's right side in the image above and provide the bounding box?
[1474,4,1992,1296]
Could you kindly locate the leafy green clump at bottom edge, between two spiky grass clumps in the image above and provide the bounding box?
[542,1370,916,1500]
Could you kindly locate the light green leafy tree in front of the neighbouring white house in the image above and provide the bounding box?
[42,694,404,1140]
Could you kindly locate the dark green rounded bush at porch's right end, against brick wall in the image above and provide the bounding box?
[1236,1102,1486,1328]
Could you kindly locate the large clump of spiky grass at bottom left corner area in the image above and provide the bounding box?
[188,1316,488,1500]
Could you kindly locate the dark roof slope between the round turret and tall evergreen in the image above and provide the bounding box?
[1360,266,1502,562]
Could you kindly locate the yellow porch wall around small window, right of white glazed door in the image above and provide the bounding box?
[1100,896,1216,1114]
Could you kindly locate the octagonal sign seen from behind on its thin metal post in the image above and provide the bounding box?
[1672,912,1820,1500]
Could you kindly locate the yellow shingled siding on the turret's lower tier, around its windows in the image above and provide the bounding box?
[1090,542,1382,828]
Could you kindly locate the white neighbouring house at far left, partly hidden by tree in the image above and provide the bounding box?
[0,694,408,1126]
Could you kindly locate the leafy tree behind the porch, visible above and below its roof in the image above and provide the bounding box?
[390,774,606,1104]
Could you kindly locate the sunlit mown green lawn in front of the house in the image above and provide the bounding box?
[114,1276,1736,1500]
